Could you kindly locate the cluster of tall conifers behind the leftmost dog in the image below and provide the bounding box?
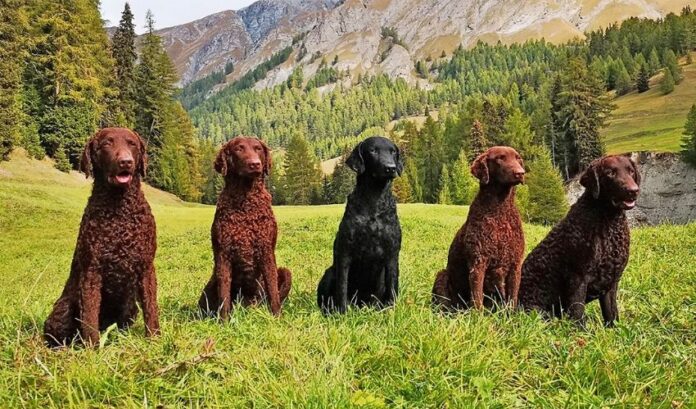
[0,0,205,201]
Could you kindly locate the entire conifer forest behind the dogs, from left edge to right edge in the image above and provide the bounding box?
[0,0,696,217]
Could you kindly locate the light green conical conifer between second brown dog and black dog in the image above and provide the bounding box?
[283,133,322,205]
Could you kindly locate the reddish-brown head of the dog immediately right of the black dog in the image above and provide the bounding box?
[471,146,525,186]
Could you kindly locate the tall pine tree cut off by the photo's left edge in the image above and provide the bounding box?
[0,0,26,160]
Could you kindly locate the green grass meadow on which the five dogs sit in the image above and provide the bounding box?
[0,151,696,408]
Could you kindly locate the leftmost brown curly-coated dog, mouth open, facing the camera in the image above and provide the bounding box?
[44,128,159,347]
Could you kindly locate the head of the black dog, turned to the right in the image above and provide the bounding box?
[346,136,404,180]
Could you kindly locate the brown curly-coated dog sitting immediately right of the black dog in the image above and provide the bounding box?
[432,146,525,309]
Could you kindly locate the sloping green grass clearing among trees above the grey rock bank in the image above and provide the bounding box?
[602,53,696,154]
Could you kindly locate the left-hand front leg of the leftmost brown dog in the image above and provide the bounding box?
[80,266,102,346]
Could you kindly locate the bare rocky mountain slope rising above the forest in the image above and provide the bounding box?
[158,0,691,87]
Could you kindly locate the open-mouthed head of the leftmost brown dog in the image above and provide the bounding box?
[80,128,147,188]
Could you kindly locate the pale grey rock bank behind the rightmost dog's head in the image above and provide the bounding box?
[566,152,696,226]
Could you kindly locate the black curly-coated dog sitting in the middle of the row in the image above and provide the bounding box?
[317,137,403,313]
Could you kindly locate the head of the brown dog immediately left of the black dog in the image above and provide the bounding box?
[215,136,271,179]
